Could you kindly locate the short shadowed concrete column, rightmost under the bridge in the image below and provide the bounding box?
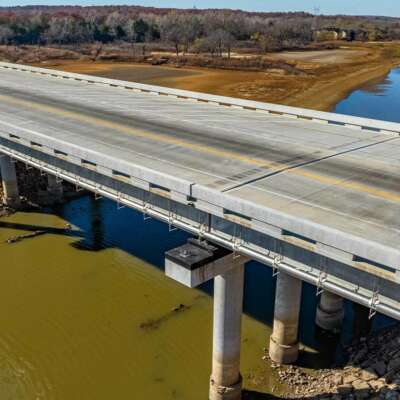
[315,291,344,331]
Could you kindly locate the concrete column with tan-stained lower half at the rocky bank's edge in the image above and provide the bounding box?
[269,272,302,364]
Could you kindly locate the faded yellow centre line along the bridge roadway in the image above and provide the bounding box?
[0,95,400,202]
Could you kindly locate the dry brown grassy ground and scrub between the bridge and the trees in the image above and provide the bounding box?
[6,43,400,110]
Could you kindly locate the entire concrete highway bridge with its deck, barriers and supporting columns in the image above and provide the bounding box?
[0,63,400,400]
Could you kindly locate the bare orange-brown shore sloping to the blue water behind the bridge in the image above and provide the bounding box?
[34,42,400,111]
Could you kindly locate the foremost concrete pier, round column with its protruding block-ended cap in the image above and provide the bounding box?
[165,239,247,400]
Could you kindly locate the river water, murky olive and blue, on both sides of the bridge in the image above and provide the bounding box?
[0,70,400,400]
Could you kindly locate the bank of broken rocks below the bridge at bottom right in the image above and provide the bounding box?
[266,318,400,400]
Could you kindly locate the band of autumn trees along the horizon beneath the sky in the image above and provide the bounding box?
[0,6,400,56]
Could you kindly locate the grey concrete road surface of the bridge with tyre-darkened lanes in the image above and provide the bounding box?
[0,68,400,267]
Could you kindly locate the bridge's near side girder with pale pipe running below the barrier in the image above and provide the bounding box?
[0,138,400,319]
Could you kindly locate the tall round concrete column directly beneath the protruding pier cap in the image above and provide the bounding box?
[210,264,244,400]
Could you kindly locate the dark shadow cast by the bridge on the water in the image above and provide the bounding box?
[4,195,391,372]
